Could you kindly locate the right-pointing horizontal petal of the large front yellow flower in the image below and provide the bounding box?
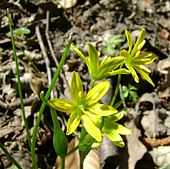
[89,103,117,116]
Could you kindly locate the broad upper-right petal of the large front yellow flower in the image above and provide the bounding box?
[86,81,110,105]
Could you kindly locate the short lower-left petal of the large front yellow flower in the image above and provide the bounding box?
[67,112,81,135]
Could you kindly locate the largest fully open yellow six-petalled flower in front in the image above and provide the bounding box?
[48,72,117,142]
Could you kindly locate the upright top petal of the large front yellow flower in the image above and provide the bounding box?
[70,72,83,101]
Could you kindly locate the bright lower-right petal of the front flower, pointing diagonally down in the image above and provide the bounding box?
[82,115,102,142]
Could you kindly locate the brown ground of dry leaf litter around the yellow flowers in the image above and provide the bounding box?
[0,0,170,169]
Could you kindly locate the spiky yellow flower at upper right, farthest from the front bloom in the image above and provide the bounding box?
[118,29,156,86]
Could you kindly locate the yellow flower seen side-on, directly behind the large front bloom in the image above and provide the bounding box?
[71,43,129,81]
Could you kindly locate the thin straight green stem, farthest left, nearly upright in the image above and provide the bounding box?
[8,11,31,148]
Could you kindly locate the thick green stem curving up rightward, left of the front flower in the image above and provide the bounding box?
[31,42,71,169]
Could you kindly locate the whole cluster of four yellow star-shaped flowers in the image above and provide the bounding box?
[48,29,156,146]
